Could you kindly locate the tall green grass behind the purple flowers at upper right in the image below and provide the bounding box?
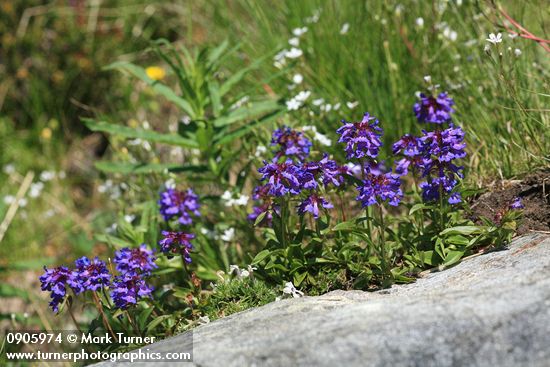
[193,0,550,181]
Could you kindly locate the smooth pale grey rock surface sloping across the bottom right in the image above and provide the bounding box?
[102,234,550,367]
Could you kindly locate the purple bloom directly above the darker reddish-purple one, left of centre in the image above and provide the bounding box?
[158,189,200,225]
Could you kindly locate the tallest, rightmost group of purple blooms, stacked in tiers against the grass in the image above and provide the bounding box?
[393,93,466,204]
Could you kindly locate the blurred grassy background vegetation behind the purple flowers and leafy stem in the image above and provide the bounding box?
[0,0,550,334]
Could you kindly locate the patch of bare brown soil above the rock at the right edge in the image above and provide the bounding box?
[472,169,550,235]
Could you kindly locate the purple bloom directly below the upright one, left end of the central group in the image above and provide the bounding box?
[258,160,303,196]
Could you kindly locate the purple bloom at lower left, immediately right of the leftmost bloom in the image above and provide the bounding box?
[67,256,111,294]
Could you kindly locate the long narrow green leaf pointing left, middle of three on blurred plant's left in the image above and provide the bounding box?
[82,118,198,148]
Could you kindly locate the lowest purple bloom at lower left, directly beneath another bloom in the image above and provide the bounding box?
[111,273,153,309]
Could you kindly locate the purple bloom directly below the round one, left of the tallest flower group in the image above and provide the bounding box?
[356,171,403,207]
